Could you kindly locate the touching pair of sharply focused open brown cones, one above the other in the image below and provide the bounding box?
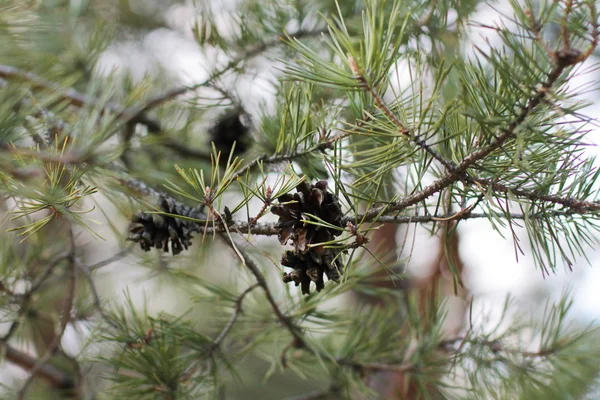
[271,181,343,294]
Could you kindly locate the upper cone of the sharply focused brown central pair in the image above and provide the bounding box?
[271,181,343,251]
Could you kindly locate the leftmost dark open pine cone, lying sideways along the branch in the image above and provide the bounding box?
[129,196,204,255]
